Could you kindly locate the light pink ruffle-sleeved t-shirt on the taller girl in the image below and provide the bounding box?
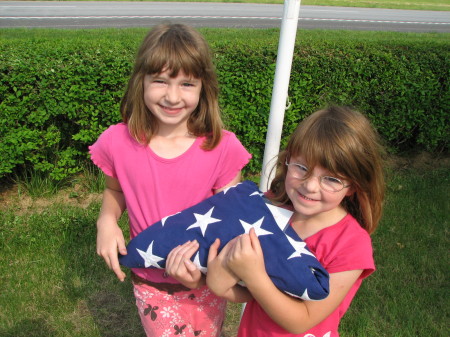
[89,123,251,282]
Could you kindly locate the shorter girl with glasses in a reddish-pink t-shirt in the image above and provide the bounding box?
[207,107,384,337]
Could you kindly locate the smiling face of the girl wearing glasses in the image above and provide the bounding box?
[285,156,353,223]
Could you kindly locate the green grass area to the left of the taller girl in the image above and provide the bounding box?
[0,198,145,337]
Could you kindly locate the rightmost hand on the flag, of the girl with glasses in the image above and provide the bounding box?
[226,228,267,285]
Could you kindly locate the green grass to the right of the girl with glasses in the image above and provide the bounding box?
[342,162,450,337]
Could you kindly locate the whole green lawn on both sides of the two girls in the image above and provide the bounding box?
[0,160,450,337]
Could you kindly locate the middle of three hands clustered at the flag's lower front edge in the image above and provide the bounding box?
[206,239,239,297]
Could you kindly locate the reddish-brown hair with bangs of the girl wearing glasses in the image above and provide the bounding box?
[271,106,385,234]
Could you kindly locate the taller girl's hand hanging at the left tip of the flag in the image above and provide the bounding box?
[97,221,127,282]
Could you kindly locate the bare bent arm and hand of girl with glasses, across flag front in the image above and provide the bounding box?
[227,229,362,334]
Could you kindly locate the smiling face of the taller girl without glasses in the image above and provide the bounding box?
[144,69,202,132]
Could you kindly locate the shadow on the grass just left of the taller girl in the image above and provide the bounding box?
[60,205,145,337]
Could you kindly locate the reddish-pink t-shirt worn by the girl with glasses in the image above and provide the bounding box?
[238,215,375,337]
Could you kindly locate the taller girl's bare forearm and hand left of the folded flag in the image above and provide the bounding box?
[97,176,127,281]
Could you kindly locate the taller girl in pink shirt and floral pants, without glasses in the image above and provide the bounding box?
[90,24,251,337]
